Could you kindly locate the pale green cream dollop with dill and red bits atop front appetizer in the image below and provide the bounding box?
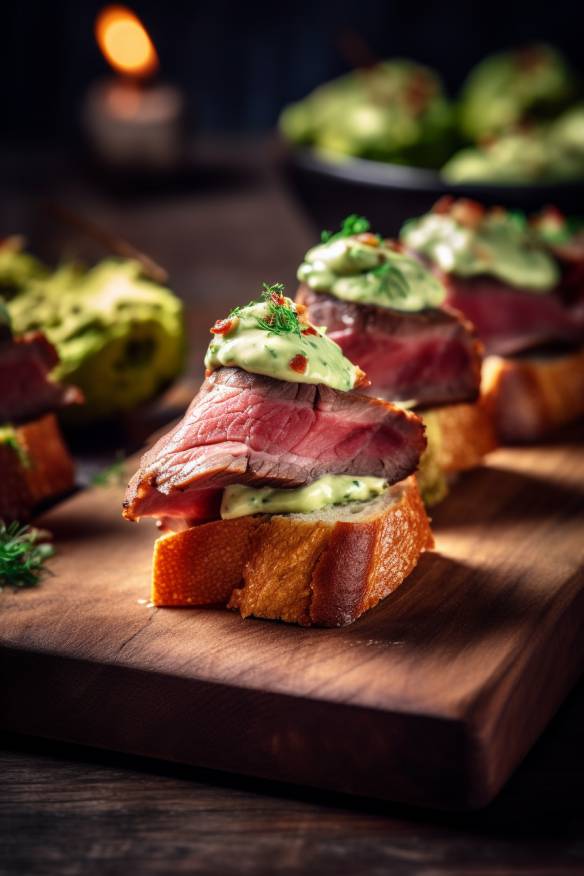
[205,283,362,391]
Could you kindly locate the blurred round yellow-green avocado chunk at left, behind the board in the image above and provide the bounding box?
[8,260,186,421]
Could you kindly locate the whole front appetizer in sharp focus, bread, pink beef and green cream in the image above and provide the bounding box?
[124,284,432,626]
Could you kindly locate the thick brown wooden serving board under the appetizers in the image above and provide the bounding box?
[0,430,584,807]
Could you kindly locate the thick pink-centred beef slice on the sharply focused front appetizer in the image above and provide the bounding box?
[124,368,425,519]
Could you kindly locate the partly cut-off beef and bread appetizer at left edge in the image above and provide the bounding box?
[0,308,82,523]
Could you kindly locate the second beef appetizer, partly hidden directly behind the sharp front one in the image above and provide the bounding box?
[297,215,495,504]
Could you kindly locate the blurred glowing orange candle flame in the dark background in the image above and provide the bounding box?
[95,6,158,78]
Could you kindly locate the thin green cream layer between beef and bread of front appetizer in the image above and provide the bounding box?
[221,475,387,520]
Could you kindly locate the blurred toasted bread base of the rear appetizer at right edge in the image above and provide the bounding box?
[483,349,584,444]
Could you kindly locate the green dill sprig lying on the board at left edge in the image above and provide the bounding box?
[0,521,55,589]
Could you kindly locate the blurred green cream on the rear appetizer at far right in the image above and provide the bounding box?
[400,210,559,292]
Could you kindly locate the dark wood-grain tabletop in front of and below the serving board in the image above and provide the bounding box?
[0,684,584,876]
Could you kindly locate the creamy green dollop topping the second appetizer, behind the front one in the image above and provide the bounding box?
[298,234,445,311]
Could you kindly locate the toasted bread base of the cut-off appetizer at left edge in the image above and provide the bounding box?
[0,414,75,521]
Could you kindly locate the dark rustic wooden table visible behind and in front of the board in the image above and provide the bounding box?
[0,141,584,876]
